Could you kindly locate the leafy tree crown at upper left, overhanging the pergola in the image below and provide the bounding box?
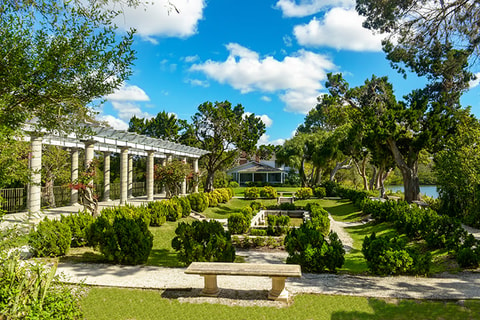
[0,0,134,134]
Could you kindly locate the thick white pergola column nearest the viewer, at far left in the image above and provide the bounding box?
[28,135,42,213]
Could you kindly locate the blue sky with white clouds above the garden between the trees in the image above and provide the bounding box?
[98,0,480,144]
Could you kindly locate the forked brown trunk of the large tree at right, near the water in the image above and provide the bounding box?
[387,138,421,203]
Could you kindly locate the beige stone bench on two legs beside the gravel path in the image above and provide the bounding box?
[185,262,302,302]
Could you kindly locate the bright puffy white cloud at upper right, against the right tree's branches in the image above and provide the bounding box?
[293,8,385,51]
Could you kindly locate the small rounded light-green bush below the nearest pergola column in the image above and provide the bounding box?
[28,217,72,257]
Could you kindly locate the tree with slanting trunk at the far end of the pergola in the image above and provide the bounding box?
[192,101,265,191]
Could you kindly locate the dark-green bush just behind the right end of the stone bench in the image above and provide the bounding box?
[285,222,345,273]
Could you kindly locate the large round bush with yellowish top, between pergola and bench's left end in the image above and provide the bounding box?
[87,207,153,265]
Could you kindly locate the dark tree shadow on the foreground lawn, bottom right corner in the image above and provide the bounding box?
[331,298,480,320]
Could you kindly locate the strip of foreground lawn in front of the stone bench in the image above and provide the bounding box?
[81,287,480,320]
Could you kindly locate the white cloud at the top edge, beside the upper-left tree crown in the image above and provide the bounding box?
[109,0,206,43]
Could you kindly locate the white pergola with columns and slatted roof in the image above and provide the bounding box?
[25,125,208,213]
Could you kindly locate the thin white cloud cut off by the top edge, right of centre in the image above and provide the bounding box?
[275,0,355,17]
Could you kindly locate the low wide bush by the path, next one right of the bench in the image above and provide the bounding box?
[362,232,431,275]
